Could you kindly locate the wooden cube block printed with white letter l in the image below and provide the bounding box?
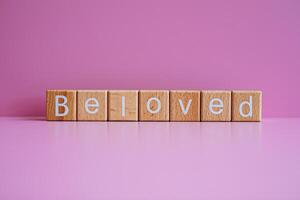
[108,90,138,121]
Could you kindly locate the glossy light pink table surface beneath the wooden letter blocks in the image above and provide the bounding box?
[0,117,300,200]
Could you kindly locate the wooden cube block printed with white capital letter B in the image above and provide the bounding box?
[46,90,76,121]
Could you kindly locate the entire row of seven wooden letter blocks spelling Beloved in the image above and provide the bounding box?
[46,90,262,121]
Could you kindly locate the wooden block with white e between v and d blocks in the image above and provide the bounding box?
[201,90,231,121]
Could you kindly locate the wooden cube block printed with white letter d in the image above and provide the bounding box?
[232,90,262,122]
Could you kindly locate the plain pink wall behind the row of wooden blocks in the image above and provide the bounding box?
[0,0,300,117]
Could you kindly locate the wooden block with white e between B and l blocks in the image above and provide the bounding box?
[77,90,107,121]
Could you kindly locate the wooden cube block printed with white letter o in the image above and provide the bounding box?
[139,90,169,121]
